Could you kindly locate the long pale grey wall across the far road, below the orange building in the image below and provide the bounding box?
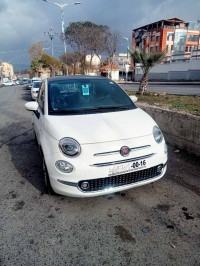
[135,59,200,81]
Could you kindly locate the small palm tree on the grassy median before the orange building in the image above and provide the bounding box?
[130,49,165,94]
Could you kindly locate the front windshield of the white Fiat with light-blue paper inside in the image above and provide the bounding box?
[48,78,137,114]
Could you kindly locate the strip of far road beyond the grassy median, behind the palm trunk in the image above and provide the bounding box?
[120,83,200,96]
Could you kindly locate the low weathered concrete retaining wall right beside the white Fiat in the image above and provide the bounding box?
[137,103,200,156]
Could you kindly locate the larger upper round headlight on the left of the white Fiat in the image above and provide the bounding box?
[59,138,81,157]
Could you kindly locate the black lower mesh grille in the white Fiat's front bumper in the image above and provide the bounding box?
[78,164,163,192]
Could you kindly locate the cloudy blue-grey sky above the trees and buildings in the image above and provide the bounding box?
[0,0,200,68]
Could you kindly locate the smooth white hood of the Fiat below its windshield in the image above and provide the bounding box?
[45,108,156,144]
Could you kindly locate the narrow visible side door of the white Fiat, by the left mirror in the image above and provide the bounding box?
[33,81,45,145]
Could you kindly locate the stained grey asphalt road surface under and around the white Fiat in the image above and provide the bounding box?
[0,86,200,266]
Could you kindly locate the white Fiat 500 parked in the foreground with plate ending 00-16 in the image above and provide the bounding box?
[25,76,167,197]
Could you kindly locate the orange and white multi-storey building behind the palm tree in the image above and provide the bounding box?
[132,18,200,56]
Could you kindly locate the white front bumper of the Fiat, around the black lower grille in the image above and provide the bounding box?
[45,144,167,197]
